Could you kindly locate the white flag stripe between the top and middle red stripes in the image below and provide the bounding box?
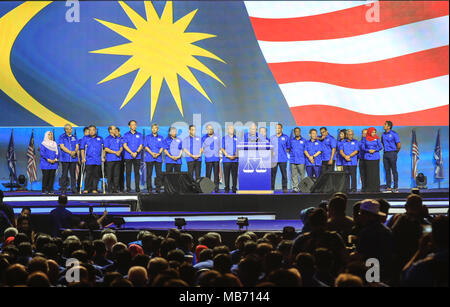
[258,16,449,64]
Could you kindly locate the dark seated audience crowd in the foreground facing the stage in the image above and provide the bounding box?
[0,193,449,287]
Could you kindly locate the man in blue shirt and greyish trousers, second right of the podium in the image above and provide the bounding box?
[290,127,306,193]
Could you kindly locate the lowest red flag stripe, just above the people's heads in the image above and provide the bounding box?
[291,105,449,126]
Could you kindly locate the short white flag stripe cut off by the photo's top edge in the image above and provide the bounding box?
[245,1,374,18]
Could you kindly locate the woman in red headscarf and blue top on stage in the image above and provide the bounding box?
[362,127,383,192]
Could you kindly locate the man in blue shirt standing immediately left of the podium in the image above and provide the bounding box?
[221,125,239,193]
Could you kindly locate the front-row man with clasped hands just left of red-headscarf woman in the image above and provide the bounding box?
[339,129,359,192]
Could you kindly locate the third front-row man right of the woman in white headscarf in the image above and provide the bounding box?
[104,126,123,193]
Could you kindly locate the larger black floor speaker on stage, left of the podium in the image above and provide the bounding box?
[162,172,201,195]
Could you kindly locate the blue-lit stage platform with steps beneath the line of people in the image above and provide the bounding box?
[4,189,449,238]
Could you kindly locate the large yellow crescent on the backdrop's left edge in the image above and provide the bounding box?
[0,1,76,127]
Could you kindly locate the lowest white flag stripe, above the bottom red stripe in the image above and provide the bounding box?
[280,75,449,115]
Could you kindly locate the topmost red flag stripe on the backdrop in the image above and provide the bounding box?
[250,1,449,42]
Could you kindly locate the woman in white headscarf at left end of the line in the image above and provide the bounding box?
[39,131,58,194]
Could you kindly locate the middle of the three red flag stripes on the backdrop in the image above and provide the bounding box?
[269,46,449,89]
